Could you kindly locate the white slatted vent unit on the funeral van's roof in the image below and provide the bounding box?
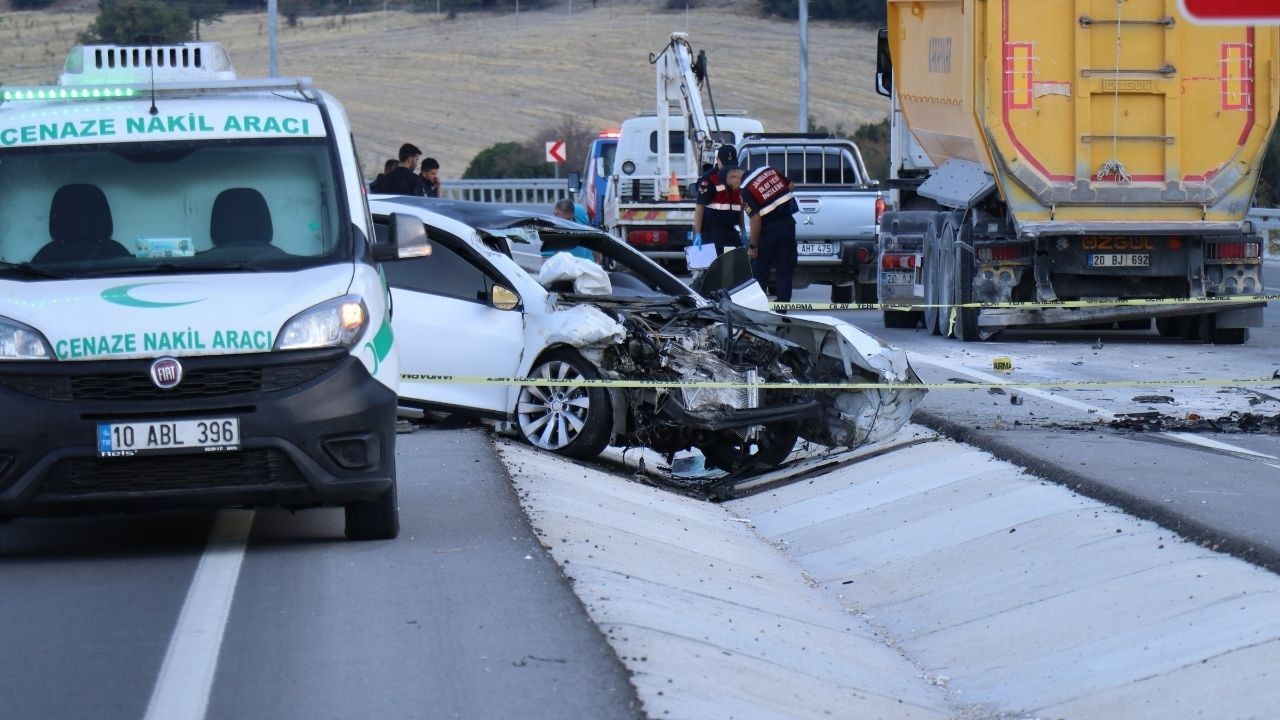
[58,42,236,86]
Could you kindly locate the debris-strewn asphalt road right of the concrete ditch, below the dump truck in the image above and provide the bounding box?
[795,280,1280,570]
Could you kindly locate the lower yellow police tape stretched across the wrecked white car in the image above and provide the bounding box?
[401,373,1280,391]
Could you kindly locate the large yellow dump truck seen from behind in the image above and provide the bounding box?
[877,0,1280,343]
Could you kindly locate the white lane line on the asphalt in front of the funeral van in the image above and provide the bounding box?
[145,510,253,720]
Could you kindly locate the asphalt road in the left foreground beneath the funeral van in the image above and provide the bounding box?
[0,430,640,720]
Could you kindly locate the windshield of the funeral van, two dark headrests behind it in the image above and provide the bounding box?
[0,138,352,279]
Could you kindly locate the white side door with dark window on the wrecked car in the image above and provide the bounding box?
[375,218,525,413]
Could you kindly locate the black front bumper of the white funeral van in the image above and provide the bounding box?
[0,350,396,516]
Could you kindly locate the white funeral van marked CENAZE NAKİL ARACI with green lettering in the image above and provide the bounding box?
[0,42,426,539]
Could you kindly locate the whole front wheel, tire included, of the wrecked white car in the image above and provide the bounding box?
[516,348,613,459]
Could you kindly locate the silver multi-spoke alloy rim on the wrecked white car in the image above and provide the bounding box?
[516,360,591,450]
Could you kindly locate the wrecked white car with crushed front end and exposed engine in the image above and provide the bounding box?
[370,197,925,473]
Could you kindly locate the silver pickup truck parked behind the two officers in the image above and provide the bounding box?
[737,133,884,302]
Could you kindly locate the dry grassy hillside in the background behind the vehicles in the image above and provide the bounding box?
[0,0,888,178]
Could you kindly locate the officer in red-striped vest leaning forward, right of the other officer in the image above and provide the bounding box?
[730,165,800,302]
